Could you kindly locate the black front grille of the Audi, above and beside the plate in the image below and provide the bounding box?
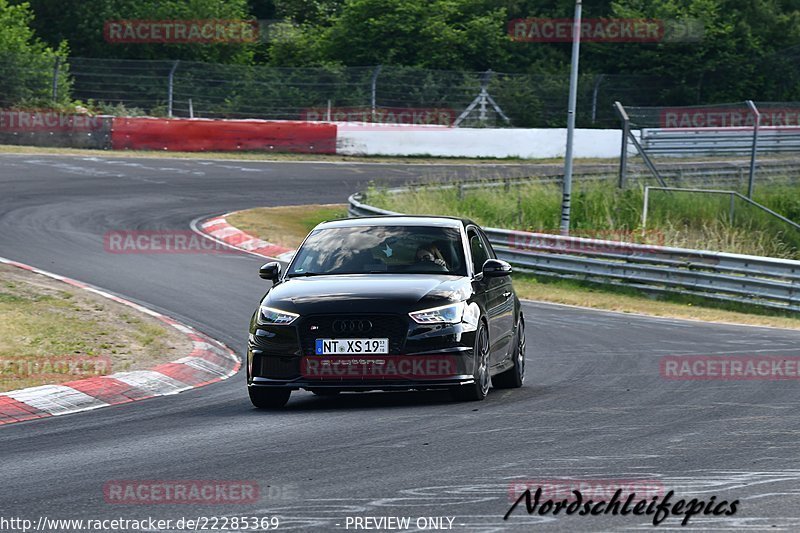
[297,315,408,355]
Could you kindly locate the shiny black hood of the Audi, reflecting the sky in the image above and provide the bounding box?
[262,274,472,315]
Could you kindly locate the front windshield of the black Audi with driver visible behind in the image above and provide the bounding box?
[287,226,466,277]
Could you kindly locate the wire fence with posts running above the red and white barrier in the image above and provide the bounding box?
[0,51,708,128]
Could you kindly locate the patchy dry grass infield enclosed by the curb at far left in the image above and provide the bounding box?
[0,265,192,392]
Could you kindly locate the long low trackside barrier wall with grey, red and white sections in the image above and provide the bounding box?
[0,111,621,159]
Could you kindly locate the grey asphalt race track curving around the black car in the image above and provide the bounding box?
[0,155,800,531]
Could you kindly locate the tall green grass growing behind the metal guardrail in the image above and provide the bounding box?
[366,180,800,259]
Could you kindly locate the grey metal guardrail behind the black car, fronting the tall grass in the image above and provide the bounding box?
[348,192,800,311]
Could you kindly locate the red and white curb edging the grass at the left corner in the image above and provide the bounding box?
[0,257,242,425]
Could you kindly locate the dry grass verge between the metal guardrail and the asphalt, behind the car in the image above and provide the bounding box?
[228,204,800,329]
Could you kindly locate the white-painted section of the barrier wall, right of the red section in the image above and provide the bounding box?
[336,123,622,159]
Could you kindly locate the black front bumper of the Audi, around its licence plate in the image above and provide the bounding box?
[247,315,475,390]
